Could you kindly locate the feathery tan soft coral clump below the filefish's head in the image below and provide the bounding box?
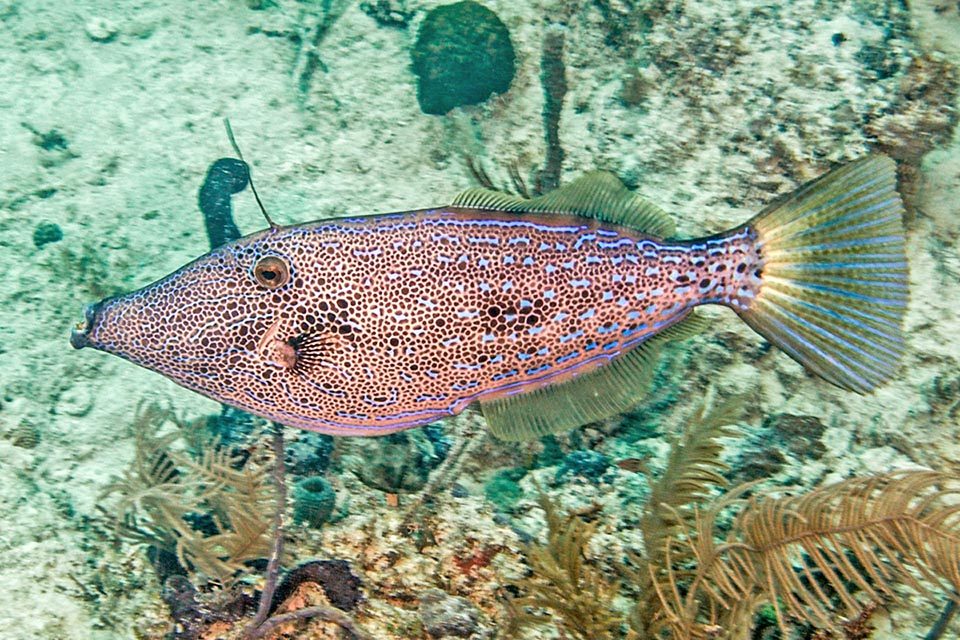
[106,404,274,584]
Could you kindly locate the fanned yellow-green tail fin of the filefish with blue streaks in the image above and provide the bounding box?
[738,156,908,393]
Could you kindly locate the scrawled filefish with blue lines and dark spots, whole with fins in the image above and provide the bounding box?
[71,156,908,440]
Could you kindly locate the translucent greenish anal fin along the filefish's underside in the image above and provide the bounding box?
[480,313,708,442]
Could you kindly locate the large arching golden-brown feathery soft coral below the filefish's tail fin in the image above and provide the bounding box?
[657,471,960,638]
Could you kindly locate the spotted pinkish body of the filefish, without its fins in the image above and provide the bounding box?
[72,208,761,435]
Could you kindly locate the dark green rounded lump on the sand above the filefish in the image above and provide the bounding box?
[411,0,516,115]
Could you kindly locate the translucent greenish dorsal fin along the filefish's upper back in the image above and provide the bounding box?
[451,171,676,238]
